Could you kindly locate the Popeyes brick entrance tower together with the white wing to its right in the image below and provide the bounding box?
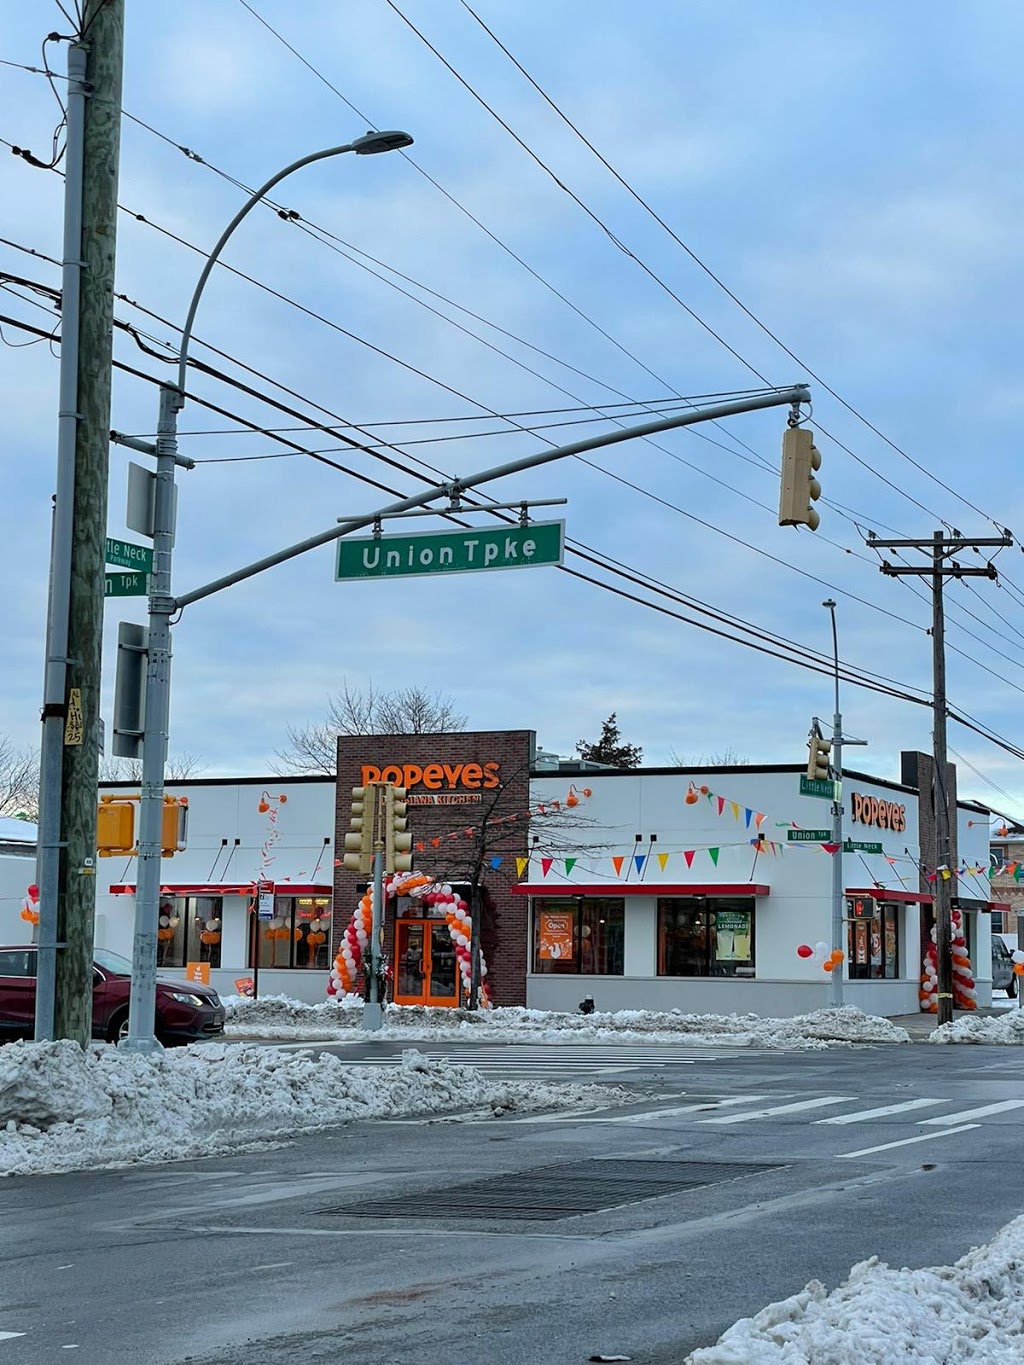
[335,732,994,1016]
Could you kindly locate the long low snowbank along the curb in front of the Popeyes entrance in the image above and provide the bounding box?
[225,995,911,1051]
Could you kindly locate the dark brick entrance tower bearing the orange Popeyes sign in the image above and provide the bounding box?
[332,730,537,1005]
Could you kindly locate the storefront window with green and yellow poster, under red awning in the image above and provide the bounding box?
[658,897,754,976]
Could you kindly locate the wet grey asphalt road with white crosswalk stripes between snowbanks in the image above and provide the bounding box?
[0,1043,1024,1365]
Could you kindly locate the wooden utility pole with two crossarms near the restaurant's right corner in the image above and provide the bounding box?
[867,531,1013,1024]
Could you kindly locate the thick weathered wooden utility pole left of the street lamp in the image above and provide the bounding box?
[45,0,124,1047]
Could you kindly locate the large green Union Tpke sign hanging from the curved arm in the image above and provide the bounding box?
[335,521,565,581]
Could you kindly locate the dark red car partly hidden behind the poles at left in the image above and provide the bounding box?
[0,943,224,1047]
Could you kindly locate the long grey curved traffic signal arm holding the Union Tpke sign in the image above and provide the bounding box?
[178,384,819,612]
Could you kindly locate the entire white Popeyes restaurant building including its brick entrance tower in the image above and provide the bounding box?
[0,730,1004,1016]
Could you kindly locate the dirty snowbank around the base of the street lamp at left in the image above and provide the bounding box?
[0,1041,625,1175]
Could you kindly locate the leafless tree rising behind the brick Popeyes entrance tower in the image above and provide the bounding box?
[277,680,466,777]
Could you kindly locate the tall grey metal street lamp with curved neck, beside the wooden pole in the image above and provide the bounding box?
[122,131,412,1052]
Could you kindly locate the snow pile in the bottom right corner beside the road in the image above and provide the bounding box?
[687,1218,1024,1365]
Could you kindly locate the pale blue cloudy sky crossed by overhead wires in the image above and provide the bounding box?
[0,0,1024,818]
